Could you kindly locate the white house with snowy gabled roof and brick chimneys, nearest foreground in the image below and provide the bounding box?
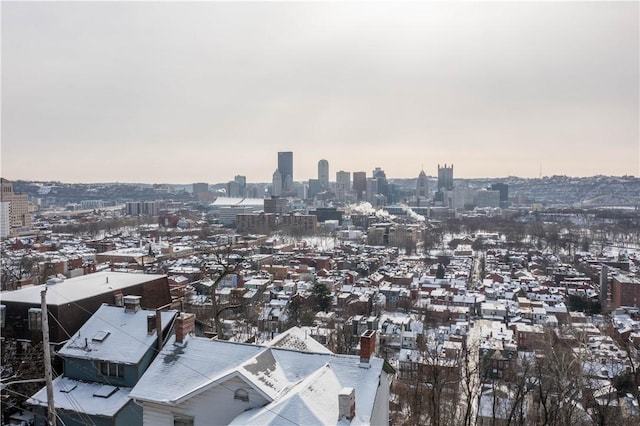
[129,318,394,426]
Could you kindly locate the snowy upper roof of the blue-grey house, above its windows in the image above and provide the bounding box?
[59,305,177,364]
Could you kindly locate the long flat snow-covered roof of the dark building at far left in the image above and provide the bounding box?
[0,271,166,305]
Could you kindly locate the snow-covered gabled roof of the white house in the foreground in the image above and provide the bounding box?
[131,332,384,424]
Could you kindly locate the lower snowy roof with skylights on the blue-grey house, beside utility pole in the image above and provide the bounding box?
[27,376,131,417]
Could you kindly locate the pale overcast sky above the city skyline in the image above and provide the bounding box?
[0,1,640,183]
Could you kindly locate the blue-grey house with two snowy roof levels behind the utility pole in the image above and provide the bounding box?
[27,296,177,426]
